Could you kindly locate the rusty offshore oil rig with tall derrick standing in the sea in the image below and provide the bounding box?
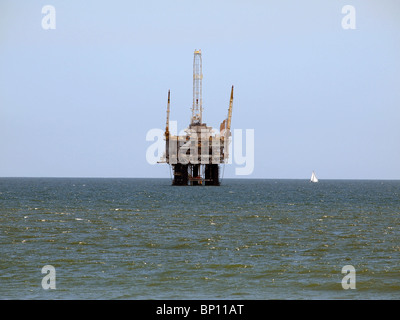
[159,50,233,186]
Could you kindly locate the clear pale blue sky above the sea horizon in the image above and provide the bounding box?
[0,0,400,181]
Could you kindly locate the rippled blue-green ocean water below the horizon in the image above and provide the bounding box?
[0,178,400,300]
